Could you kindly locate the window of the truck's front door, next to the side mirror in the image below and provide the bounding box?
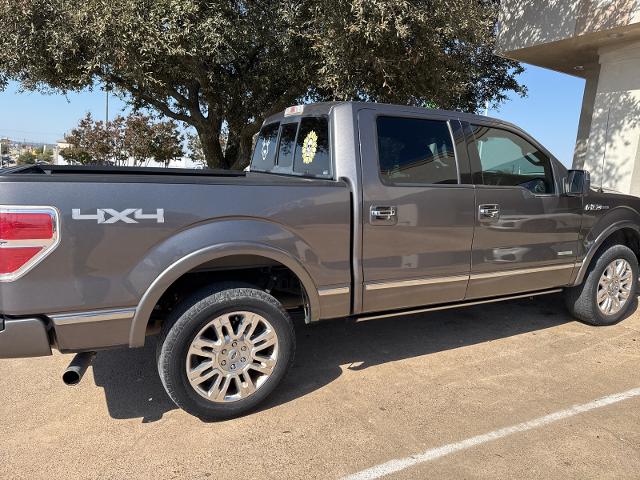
[472,125,555,195]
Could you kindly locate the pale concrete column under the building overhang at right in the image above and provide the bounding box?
[574,42,640,195]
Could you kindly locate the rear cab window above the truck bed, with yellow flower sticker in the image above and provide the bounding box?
[250,116,333,178]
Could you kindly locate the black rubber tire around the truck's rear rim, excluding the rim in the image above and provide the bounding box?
[157,283,295,420]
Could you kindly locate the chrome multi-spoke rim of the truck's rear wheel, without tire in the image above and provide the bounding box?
[186,311,278,403]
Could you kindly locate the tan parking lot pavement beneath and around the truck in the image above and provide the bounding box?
[0,295,640,480]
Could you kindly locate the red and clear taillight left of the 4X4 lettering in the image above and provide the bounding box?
[0,207,59,282]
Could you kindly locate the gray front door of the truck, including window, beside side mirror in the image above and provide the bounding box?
[463,123,581,299]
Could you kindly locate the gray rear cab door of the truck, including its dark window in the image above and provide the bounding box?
[359,110,475,312]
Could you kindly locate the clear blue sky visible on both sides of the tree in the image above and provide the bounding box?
[0,65,584,166]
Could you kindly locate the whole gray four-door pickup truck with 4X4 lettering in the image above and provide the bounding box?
[0,102,640,419]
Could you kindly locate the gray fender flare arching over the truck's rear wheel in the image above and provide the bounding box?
[129,242,320,347]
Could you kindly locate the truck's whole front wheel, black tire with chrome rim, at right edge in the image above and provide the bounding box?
[565,245,638,325]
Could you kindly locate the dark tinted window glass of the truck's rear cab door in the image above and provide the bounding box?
[376,117,458,185]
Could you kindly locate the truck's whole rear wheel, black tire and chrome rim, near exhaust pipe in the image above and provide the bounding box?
[157,285,295,420]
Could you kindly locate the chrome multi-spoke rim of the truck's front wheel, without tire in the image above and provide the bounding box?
[596,258,633,315]
